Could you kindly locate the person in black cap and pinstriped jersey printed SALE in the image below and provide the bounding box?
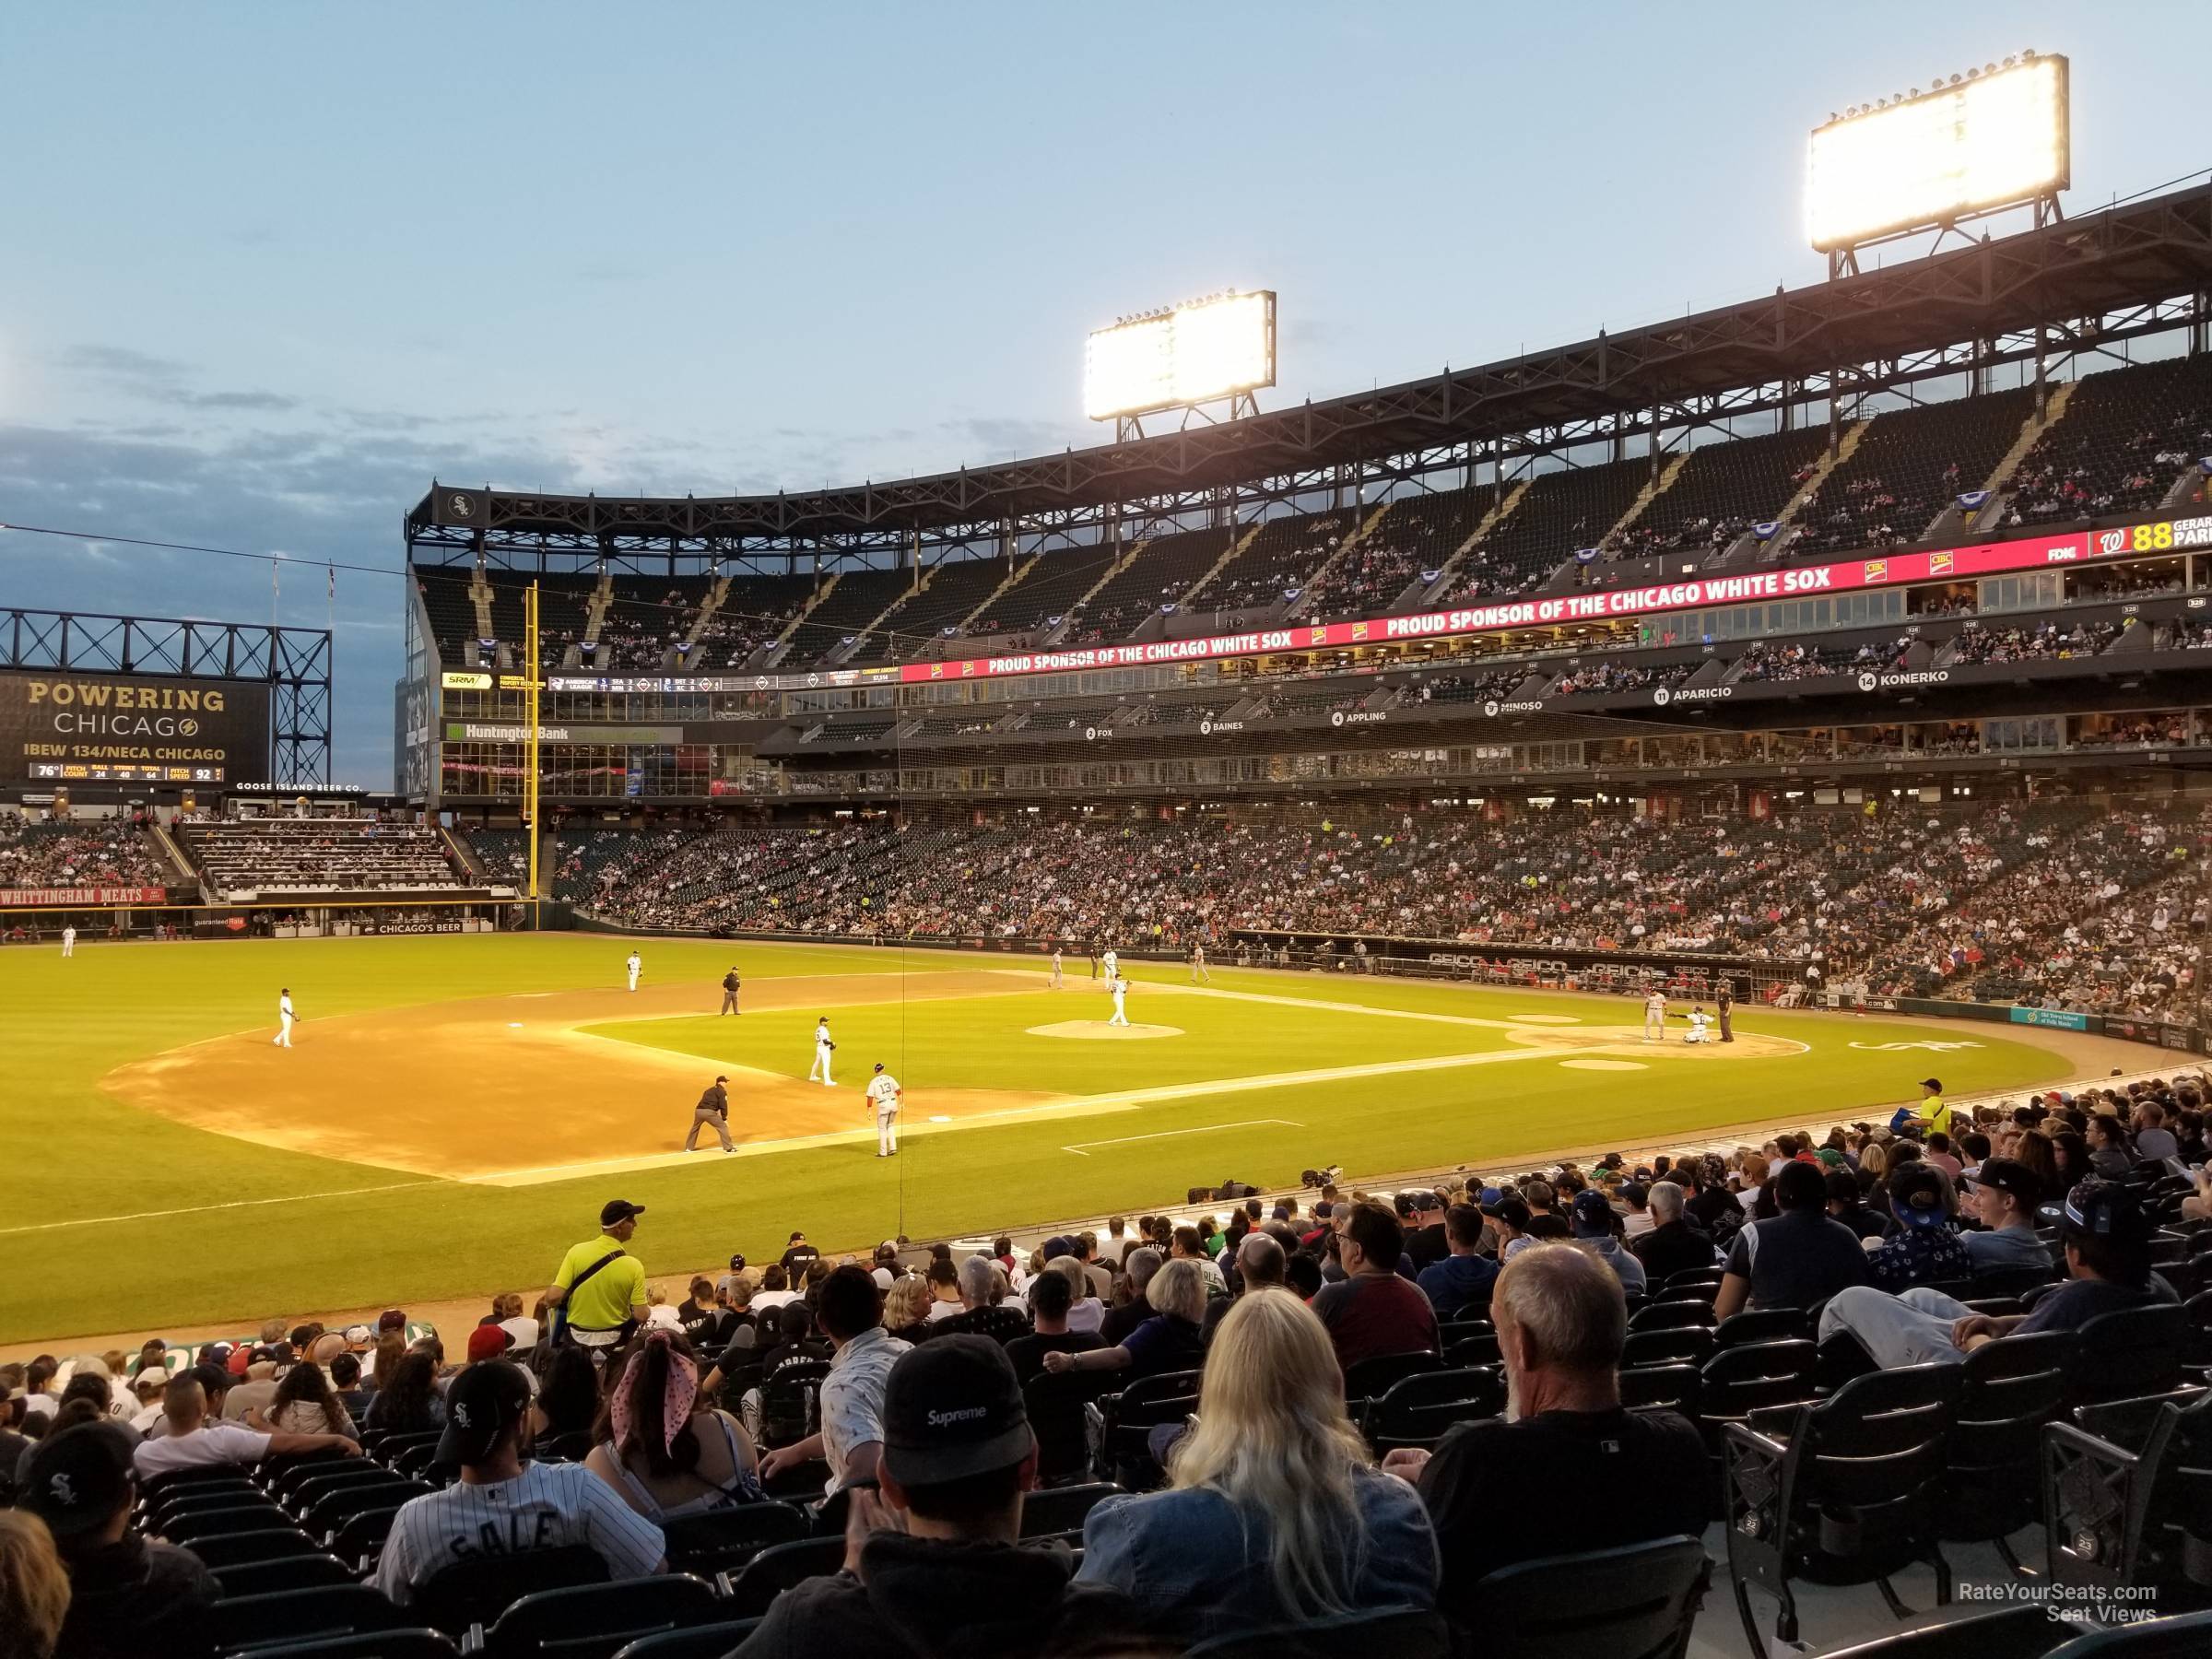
[371,1360,665,1606]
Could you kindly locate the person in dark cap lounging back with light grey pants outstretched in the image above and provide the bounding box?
[1820,1182,2174,1370]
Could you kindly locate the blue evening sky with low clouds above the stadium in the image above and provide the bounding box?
[0,0,2212,787]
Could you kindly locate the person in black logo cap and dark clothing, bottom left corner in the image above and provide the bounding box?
[16,1422,219,1654]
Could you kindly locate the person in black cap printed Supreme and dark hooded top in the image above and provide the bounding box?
[736,1335,1133,1659]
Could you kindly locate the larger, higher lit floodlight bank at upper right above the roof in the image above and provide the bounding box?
[1805,57,2073,253]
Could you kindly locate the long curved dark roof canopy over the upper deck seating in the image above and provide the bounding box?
[405,183,2212,562]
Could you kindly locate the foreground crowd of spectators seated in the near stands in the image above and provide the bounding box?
[0,1077,2212,1659]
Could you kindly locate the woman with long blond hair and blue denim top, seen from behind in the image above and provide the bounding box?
[1075,1300,1438,1641]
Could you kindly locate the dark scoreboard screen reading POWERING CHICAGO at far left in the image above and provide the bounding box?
[0,673,270,783]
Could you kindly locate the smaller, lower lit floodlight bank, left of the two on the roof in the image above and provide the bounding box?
[1084,289,1274,420]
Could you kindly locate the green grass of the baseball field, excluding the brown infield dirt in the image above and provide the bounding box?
[0,935,2066,1343]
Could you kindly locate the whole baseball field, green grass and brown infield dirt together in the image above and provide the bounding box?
[0,934,2103,1345]
